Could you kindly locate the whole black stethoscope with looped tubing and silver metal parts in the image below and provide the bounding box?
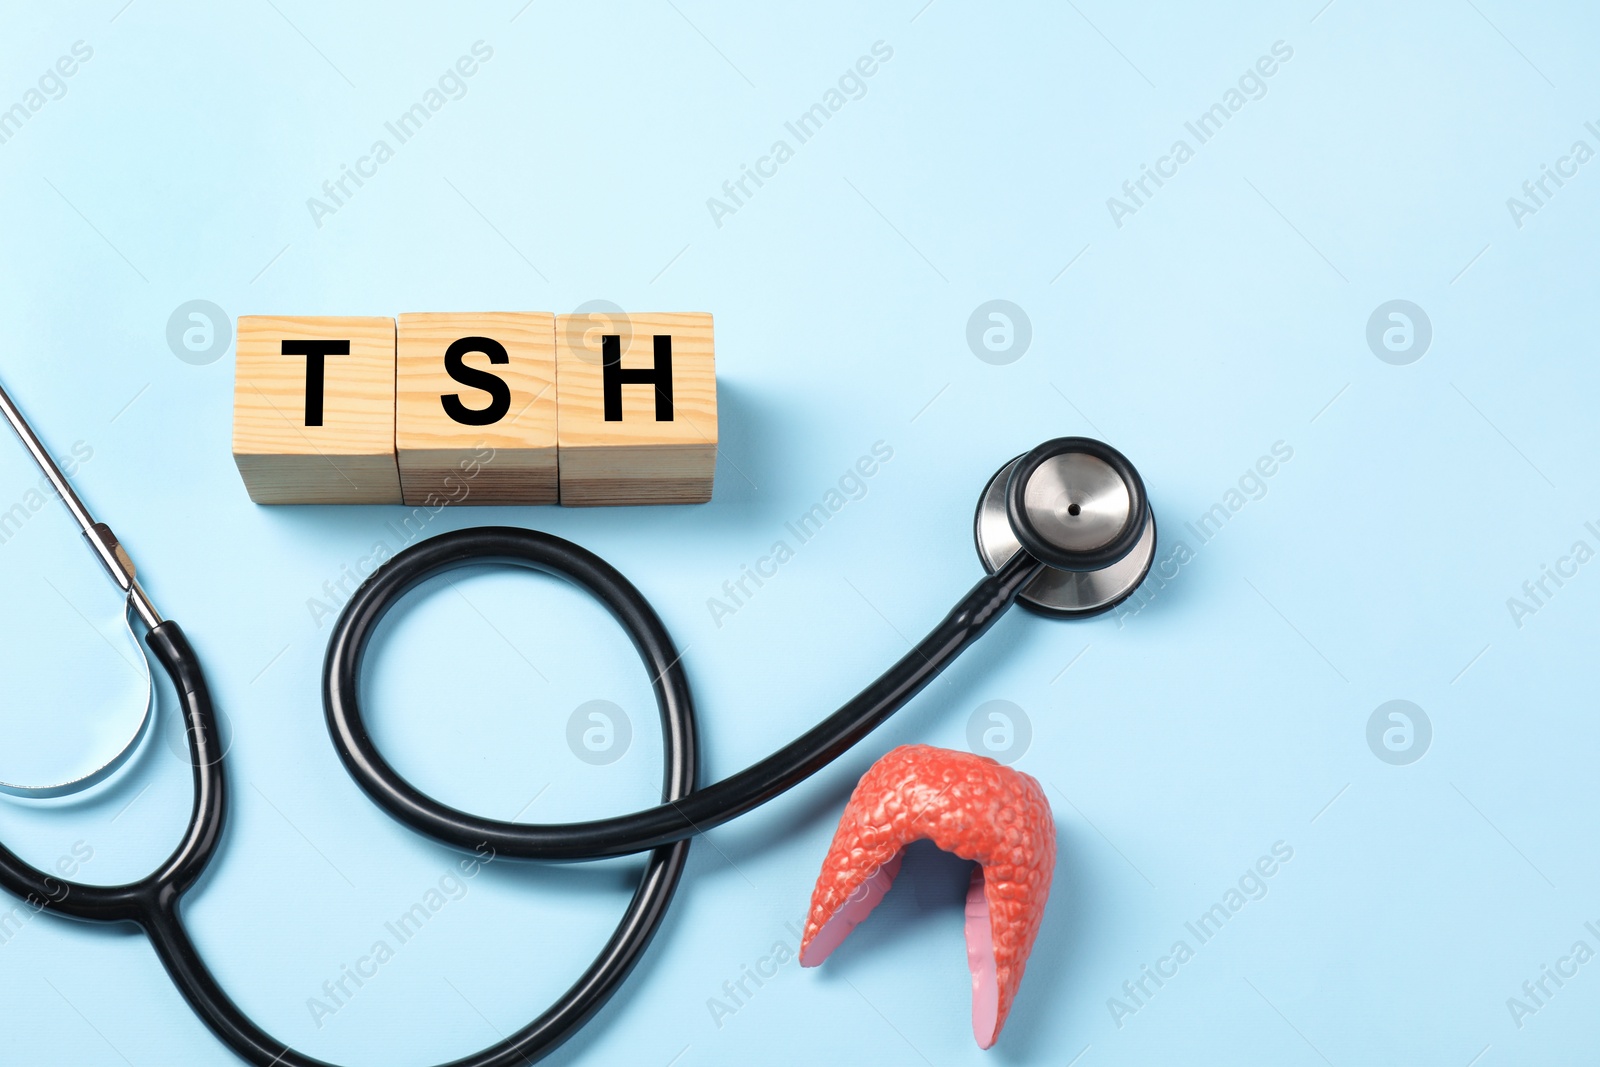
[0,377,1155,1067]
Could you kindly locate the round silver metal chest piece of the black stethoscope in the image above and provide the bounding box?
[974,437,1155,617]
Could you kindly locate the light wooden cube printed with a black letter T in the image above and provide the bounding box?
[234,315,400,504]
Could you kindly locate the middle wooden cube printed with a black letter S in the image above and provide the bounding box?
[395,312,557,506]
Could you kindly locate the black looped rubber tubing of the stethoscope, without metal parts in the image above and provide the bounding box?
[0,524,1043,1067]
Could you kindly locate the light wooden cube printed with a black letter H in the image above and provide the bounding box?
[555,312,717,507]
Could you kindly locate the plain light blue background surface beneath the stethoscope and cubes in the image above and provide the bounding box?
[0,0,1600,1067]
